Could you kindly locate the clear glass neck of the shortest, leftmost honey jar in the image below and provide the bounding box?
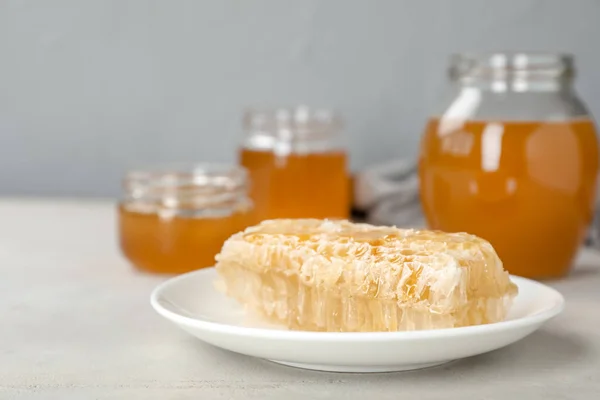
[121,164,250,217]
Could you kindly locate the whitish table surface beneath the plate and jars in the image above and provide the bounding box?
[0,200,600,400]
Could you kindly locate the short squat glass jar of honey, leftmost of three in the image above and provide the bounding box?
[118,164,255,273]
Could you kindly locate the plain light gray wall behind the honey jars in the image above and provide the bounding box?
[0,0,600,196]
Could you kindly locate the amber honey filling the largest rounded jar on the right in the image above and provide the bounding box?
[420,119,598,278]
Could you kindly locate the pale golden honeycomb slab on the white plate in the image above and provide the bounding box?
[216,219,517,332]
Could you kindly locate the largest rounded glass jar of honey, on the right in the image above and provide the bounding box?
[419,53,598,279]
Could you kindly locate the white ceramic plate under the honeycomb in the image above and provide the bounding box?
[151,268,564,372]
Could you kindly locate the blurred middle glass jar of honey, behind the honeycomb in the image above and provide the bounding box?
[239,107,350,220]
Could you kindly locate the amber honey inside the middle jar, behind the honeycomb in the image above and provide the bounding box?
[239,149,350,219]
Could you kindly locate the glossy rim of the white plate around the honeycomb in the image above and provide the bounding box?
[150,266,565,342]
